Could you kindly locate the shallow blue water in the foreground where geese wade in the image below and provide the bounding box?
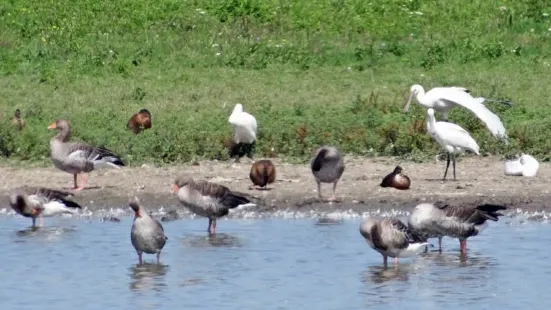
[0,209,551,310]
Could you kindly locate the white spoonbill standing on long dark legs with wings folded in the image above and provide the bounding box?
[427,108,480,182]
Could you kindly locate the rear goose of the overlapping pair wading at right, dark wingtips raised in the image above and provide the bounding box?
[408,203,507,254]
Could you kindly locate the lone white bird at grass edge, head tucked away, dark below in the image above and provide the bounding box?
[228,103,257,161]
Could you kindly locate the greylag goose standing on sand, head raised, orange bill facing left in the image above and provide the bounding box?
[48,120,124,191]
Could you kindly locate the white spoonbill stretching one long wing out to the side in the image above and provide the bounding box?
[404,85,511,141]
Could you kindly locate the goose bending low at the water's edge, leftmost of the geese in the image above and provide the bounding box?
[10,186,82,227]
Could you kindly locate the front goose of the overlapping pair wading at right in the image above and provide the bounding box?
[360,217,428,267]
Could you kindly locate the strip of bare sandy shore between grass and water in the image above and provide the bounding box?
[0,157,551,217]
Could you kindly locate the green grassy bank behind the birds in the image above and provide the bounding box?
[0,0,551,164]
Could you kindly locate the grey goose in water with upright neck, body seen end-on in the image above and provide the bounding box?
[128,197,168,264]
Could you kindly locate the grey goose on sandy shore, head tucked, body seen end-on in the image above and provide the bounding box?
[310,145,344,201]
